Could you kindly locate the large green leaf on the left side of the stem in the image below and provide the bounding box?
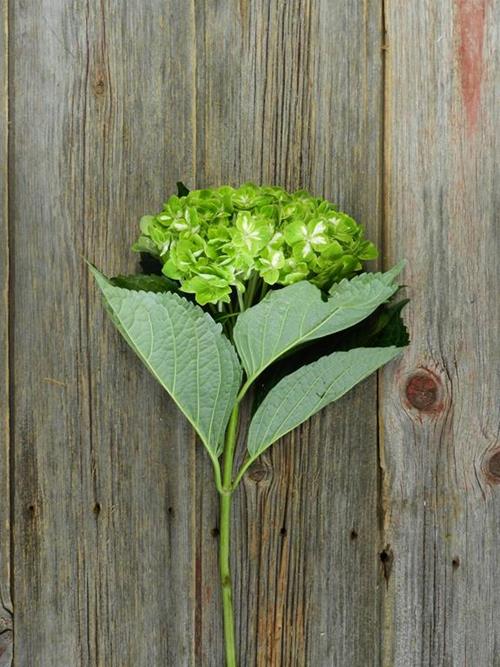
[91,267,242,457]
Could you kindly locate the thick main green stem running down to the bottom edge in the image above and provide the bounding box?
[219,405,239,667]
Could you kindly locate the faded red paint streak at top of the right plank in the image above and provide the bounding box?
[456,0,488,130]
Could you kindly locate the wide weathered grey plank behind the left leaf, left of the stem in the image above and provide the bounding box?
[11,0,195,667]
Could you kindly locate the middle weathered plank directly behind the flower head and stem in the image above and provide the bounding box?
[196,0,384,667]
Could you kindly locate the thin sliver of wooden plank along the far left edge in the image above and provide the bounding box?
[0,1,12,667]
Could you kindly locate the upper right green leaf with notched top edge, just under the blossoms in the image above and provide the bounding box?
[234,263,403,384]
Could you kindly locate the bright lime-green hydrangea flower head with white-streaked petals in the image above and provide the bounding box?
[133,184,377,306]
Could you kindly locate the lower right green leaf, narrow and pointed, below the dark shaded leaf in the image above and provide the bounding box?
[248,347,401,459]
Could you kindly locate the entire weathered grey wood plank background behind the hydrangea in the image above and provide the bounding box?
[0,0,500,667]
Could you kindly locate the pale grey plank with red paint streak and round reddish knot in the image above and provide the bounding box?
[381,0,500,667]
